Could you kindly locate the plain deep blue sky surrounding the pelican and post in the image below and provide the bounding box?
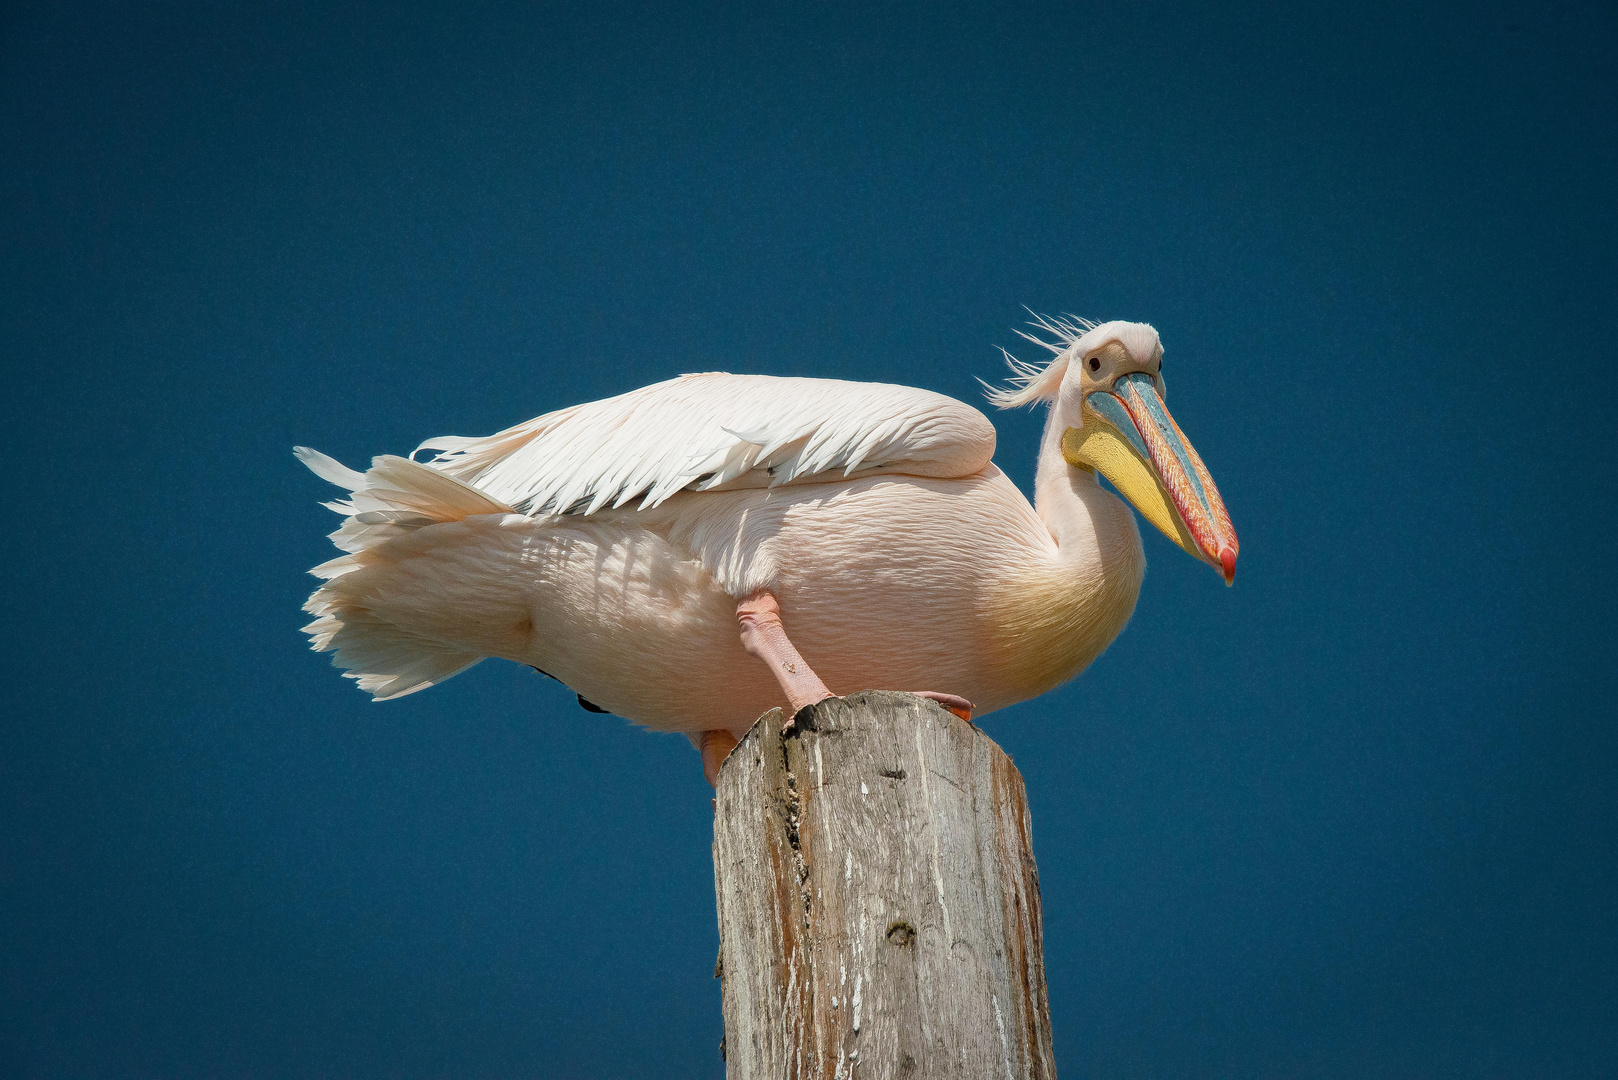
[0,3,1618,1077]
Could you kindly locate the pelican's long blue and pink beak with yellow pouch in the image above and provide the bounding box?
[1061,372,1239,585]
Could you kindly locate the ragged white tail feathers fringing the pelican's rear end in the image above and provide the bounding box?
[293,447,513,701]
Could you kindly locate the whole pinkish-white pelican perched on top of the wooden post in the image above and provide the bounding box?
[298,319,1238,780]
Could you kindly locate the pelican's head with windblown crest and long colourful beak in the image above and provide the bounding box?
[997,319,1239,585]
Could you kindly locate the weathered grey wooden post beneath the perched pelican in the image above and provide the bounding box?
[714,690,1057,1080]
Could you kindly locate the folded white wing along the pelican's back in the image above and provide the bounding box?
[416,372,995,513]
